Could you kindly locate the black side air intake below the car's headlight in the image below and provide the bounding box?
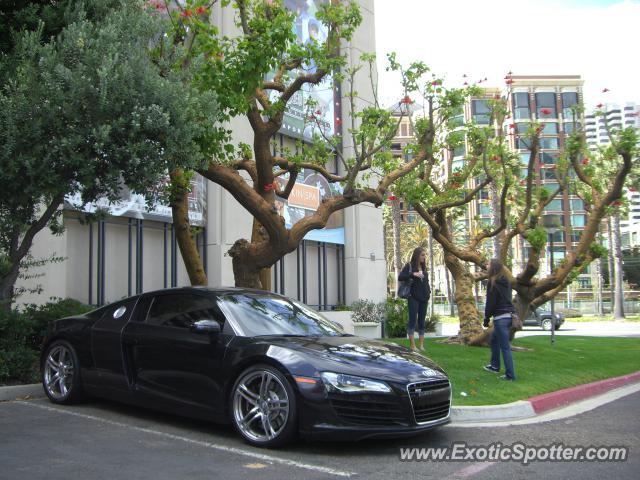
[330,397,407,425]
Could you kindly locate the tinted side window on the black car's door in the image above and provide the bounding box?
[146,294,222,328]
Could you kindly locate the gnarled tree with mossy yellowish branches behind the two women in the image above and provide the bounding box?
[392,75,637,344]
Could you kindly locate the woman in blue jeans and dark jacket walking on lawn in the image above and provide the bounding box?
[483,258,516,380]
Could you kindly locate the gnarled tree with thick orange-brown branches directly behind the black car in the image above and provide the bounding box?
[169,0,427,288]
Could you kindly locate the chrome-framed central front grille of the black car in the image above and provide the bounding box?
[407,379,451,423]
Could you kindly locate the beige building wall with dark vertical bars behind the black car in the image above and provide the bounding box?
[18,0,386,310]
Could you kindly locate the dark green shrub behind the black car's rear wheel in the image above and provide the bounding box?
[0,299,92,383]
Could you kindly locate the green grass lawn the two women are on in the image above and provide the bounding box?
[390,335,640,406]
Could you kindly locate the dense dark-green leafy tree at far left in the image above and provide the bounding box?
[0,0,219,308]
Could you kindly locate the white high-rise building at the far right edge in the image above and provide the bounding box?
[585,102,640,248]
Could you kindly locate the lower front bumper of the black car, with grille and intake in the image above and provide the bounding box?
[298,378,451,441]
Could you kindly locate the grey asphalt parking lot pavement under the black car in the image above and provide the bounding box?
[0,392,640,480]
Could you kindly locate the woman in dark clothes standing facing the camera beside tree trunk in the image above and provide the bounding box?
[398,247,431,350]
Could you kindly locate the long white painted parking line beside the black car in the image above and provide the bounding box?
[14,400,356,477]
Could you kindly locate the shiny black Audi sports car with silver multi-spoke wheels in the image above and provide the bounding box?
[41,287,451,447]
